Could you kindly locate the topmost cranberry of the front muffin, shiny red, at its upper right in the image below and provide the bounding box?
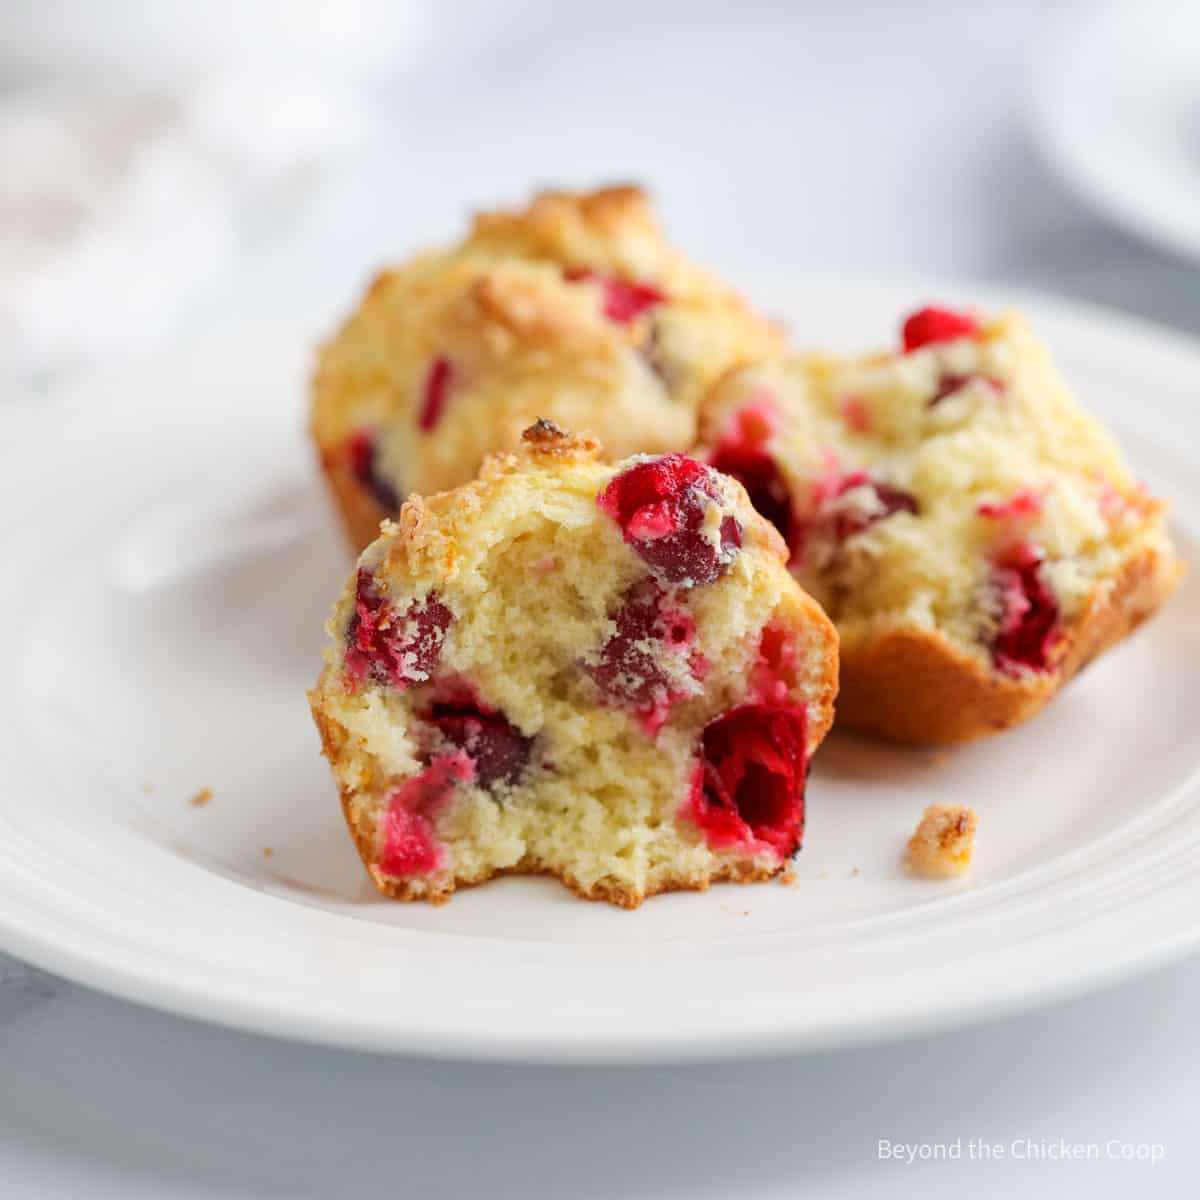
[596,454,742,587]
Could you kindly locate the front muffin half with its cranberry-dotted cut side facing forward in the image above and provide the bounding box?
[310,421,836,907]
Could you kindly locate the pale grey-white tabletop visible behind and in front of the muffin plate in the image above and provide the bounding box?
[0,0,1200,1200]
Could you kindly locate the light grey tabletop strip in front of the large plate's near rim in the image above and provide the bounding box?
[0,961,1200,1200]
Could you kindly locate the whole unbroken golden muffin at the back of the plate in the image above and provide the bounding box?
[312,187,781,548]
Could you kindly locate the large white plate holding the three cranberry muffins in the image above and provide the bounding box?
[0,282,1200,1061]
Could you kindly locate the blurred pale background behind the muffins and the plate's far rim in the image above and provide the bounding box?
[0,0,1200,395]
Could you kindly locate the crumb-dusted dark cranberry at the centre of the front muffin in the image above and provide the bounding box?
[581,580,696,734]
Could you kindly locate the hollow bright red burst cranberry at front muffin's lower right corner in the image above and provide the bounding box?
[688,704,808,858]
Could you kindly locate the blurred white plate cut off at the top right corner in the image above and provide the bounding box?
[1032,0,1200,258]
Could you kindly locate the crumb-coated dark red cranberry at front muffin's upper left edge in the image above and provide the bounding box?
[346,569,452,688]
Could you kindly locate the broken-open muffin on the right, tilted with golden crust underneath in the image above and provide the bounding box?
[700,308,1178,742]
